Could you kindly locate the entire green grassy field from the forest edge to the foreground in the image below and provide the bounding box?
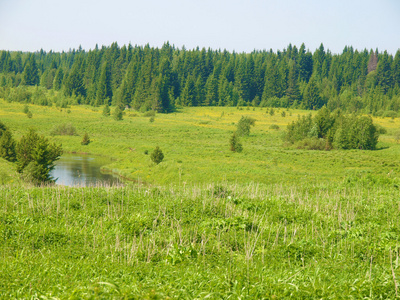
[0,101,400,299]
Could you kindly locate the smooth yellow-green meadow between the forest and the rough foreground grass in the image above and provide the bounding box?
[0,101,400,184]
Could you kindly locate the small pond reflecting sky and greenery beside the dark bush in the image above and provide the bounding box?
[51,154,121,186]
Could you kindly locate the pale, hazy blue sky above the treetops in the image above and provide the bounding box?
[0,0,400,55]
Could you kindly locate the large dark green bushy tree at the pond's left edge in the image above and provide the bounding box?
[16,129,62,184]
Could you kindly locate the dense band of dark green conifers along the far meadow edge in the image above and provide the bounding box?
[0,42,400,116]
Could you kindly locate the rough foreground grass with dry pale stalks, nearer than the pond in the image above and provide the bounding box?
[0,181,400,299]
